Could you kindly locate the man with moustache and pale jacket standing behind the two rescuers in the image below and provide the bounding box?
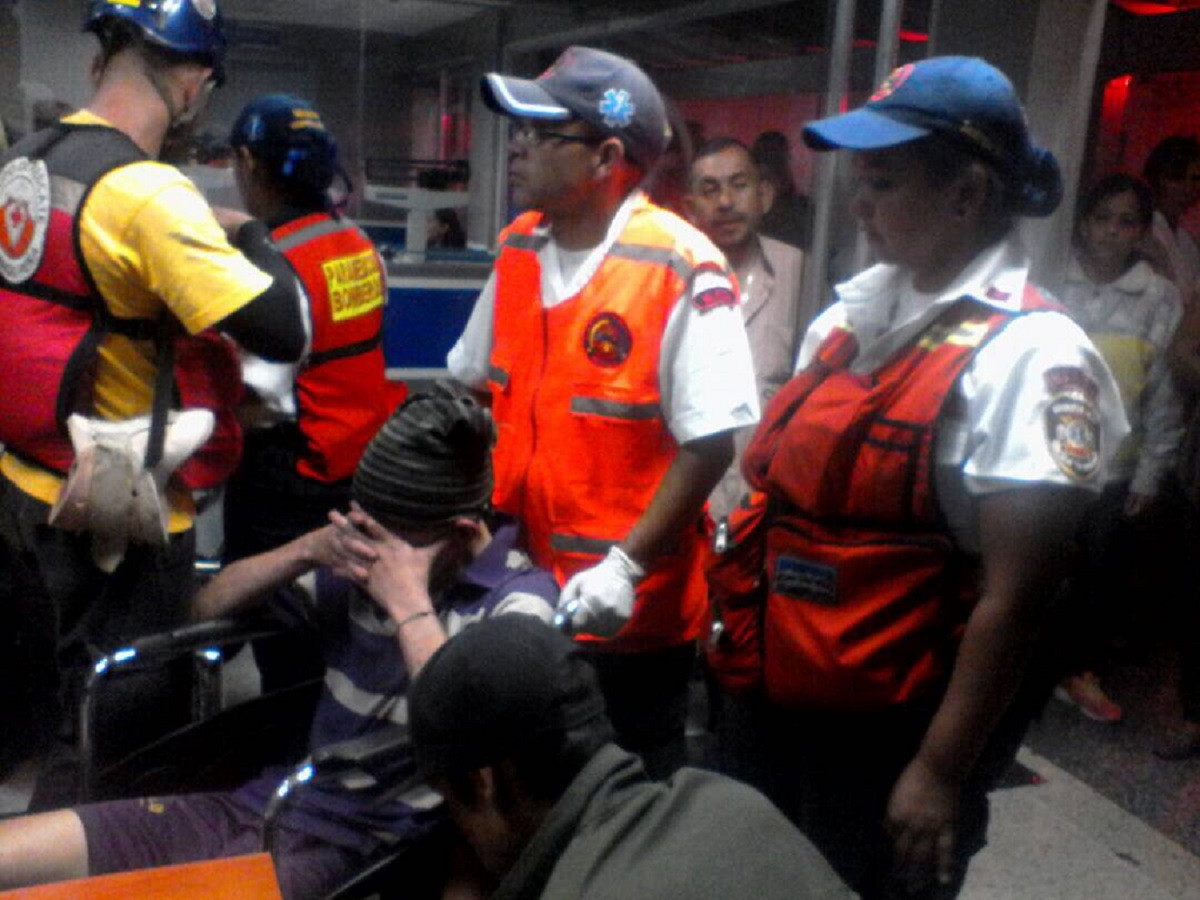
[684,138,816,518]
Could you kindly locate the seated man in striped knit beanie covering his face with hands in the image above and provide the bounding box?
[0,388,558,900]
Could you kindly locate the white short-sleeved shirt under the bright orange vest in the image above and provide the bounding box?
[446,192,758,444]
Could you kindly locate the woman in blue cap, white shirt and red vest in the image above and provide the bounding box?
[705,56,1127,898]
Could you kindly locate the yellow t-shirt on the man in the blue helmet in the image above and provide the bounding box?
[0,110,271,530]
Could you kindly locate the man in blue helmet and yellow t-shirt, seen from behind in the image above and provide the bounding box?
[0,0,304,796]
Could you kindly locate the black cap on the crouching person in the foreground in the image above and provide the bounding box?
[408,613,612,778]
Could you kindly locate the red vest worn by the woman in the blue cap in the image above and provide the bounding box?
[744,288,1045,709]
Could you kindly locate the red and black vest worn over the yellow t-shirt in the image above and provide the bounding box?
[0,122,241,487]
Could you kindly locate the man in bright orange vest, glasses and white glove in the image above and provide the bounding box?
[448,47,758,775]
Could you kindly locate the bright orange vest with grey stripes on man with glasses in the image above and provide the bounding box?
[488,196,726,650]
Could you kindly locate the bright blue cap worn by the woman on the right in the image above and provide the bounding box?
[803,56,1062,216]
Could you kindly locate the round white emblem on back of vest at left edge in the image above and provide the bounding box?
[0,158,50,284]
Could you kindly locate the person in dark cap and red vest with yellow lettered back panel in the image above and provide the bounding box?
[218,94,392,690]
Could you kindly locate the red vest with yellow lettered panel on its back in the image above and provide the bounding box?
[271,212,391,482]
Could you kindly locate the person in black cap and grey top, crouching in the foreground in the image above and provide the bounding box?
[409,616,850,900]
